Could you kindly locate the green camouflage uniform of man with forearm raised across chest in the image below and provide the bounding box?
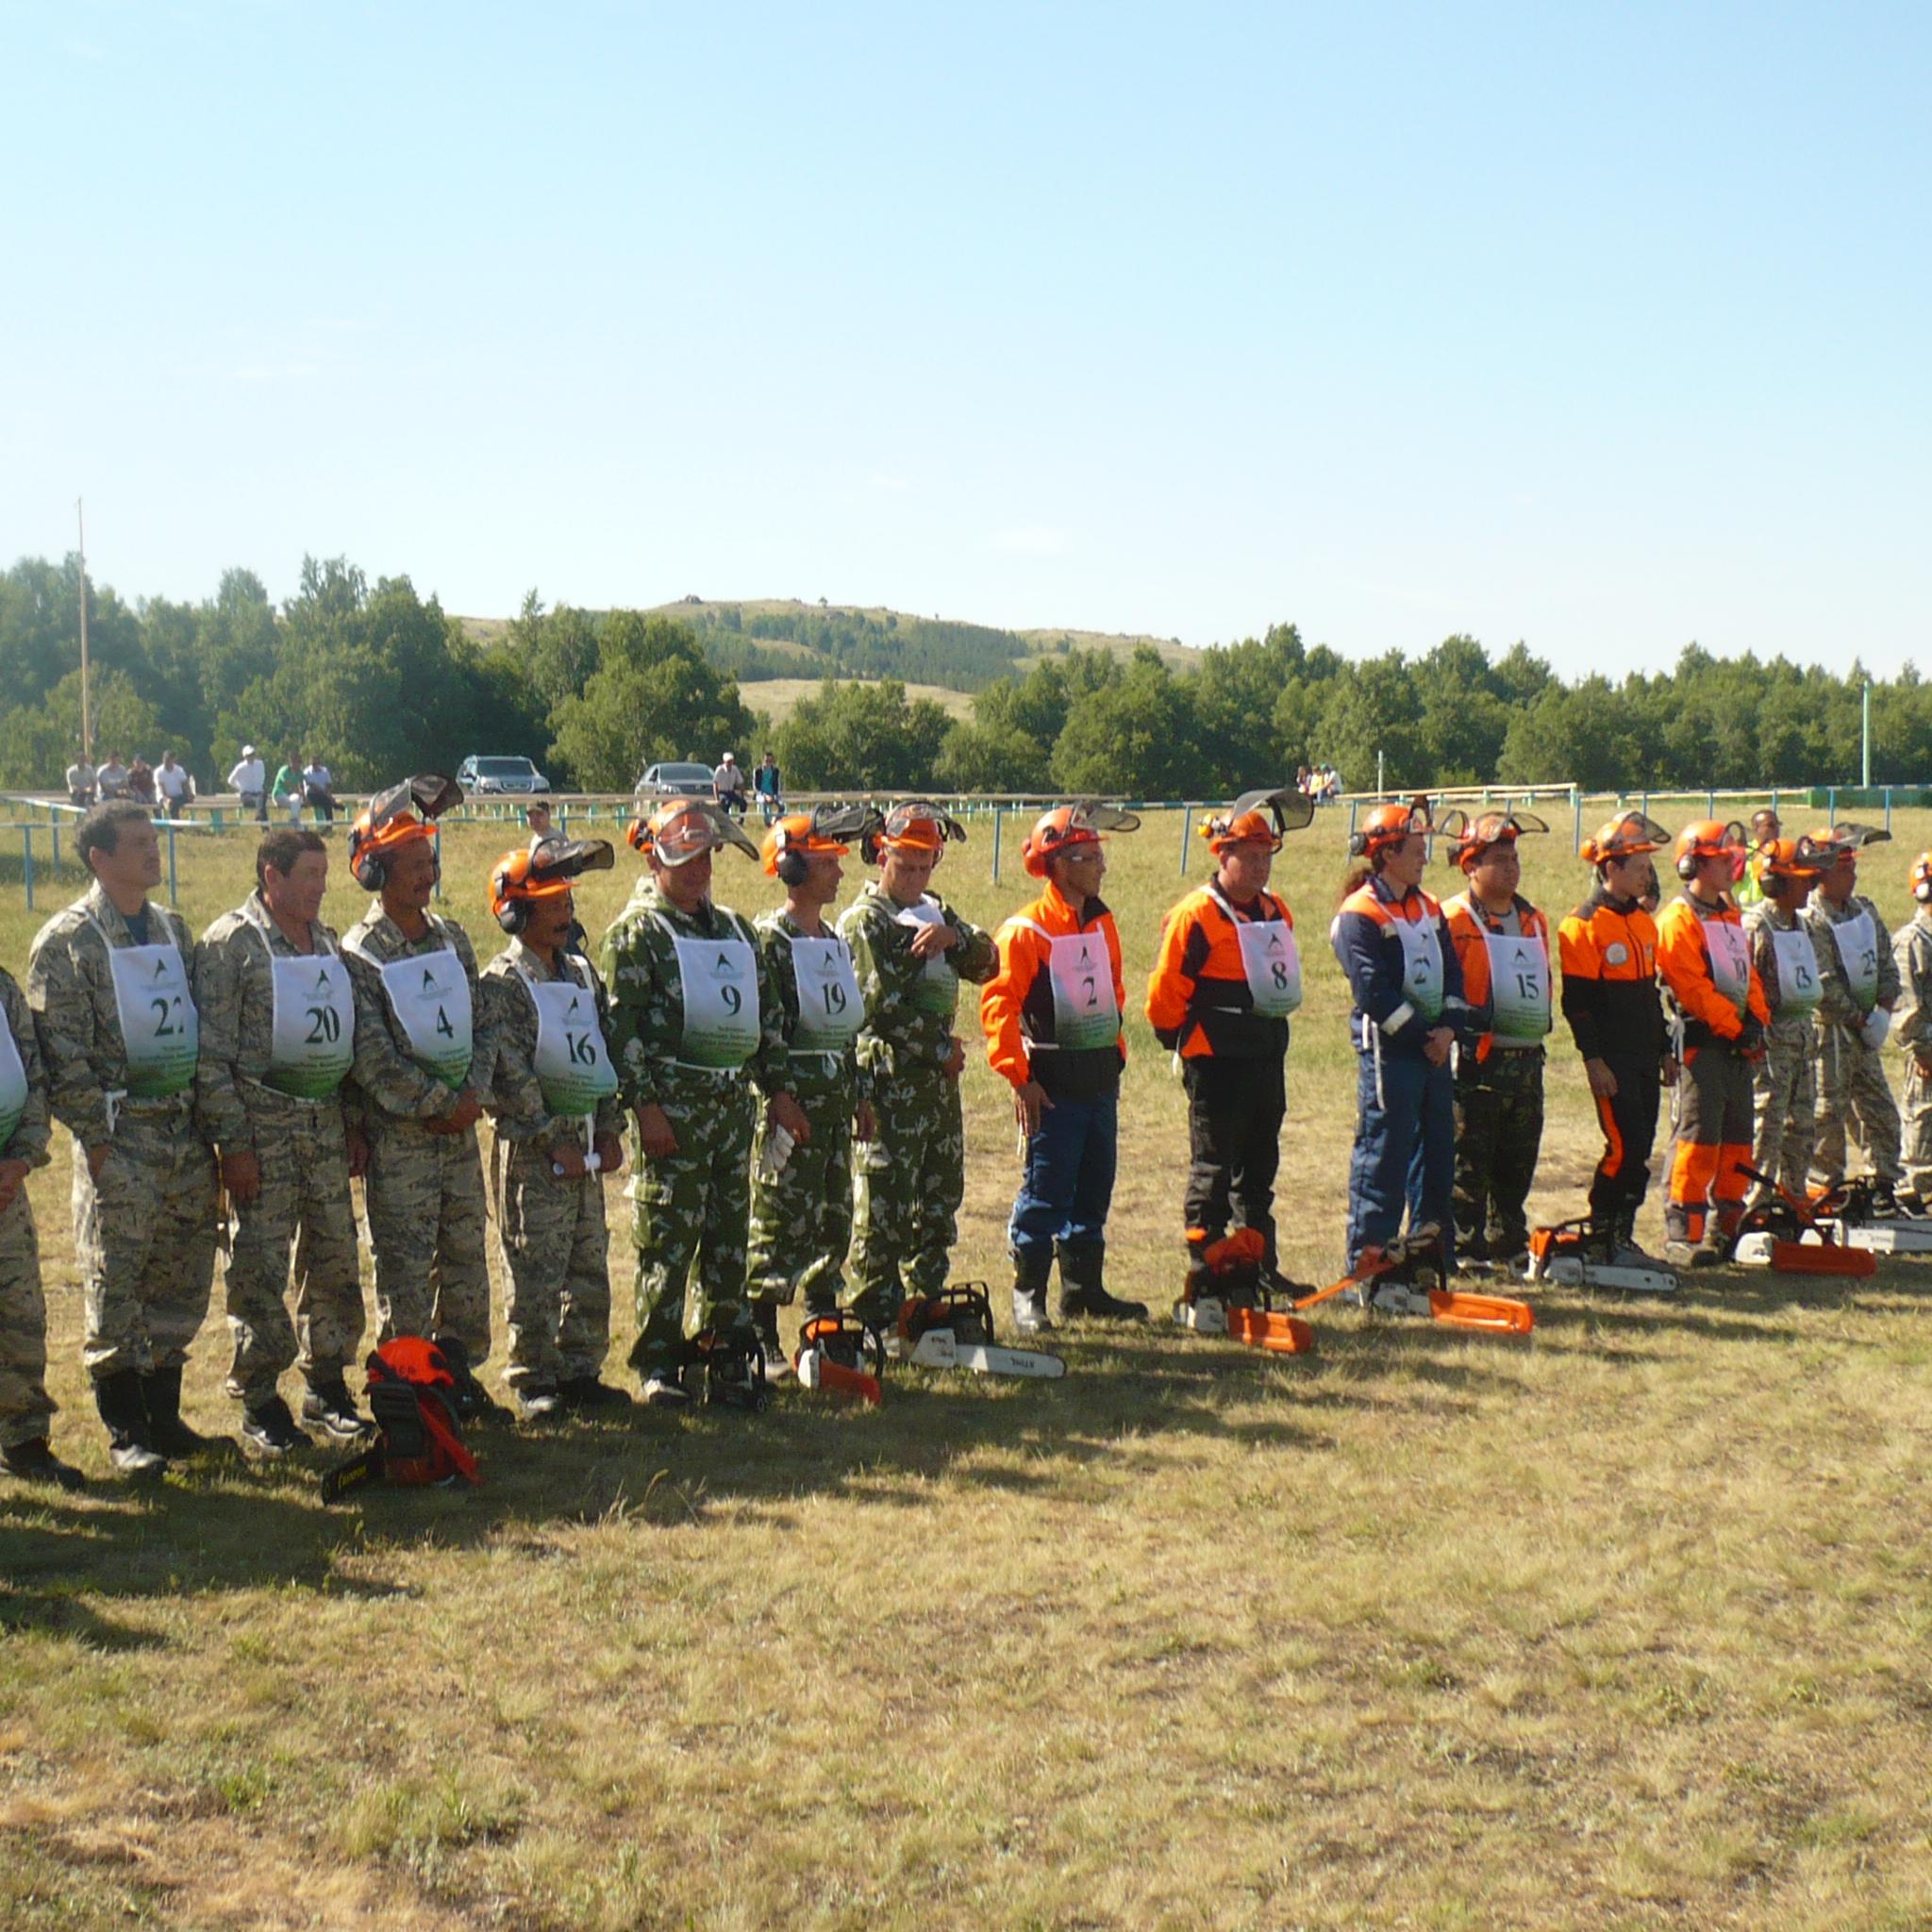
[839,881,999,1325]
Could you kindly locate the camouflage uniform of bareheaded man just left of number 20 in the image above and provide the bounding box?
[27,881,214,1377]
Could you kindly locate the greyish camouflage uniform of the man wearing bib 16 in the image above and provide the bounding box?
[481,939,625,1391]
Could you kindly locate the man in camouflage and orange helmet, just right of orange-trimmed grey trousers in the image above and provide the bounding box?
[1744,834,1832,1206]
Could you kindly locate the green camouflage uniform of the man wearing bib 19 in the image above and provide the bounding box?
[750,912,863,1316]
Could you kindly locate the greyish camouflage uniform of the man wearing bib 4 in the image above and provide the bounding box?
[341,900,491,1364]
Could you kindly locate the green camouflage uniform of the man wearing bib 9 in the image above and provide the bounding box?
[603,879,789,1379]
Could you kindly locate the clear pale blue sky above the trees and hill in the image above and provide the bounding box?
[0,0,1932,675]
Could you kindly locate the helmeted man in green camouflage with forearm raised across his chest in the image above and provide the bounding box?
[839,800,999,1329]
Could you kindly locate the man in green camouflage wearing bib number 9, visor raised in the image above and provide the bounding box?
[603,798,791,1407]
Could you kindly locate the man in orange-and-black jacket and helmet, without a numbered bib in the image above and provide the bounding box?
[1557,811,1677,1265]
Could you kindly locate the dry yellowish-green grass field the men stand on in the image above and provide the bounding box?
[0,813,1932,1932]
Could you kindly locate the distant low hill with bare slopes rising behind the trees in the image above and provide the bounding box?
[461,597,1202,709]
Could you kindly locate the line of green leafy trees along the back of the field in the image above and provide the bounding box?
[0,557,1932,798]
